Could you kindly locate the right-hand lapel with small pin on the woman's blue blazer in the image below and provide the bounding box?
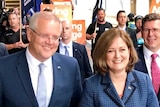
[122,72,137,103]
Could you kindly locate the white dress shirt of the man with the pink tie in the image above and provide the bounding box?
[143,45,160,79]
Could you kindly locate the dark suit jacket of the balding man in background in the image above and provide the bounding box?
[57,42,92,81]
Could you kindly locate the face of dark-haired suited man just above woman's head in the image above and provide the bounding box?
[117,12,127,26]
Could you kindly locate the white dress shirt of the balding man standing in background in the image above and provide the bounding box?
[59,41,73,57]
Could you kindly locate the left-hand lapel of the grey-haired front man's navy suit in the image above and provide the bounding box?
[17,51,38,107]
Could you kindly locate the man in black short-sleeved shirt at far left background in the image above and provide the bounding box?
[0,12,28,54]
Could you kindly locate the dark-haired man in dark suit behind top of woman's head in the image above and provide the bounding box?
[117,10,138,48]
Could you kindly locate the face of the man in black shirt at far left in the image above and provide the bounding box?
[8,14,19,28]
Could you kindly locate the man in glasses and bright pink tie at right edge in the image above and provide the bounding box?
[135,13,160,103]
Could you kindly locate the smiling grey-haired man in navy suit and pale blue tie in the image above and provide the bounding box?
[0,12,82,107]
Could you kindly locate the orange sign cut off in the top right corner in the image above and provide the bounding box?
[149,0,160,14]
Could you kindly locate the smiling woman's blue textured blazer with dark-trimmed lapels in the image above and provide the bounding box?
[79,70,159,107]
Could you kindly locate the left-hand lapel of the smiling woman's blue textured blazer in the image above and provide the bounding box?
[101,73,124,107]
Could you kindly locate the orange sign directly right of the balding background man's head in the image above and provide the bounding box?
[72,20,86,44]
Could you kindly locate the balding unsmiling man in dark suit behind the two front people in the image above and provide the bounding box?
[57,20,92,81]
